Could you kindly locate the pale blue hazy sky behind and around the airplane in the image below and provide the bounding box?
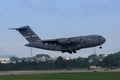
[0,0,120,57]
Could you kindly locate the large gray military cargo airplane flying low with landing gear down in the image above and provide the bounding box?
[10,26,106,54]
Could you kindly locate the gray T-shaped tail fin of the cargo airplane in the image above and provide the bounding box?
[13,26,41,42]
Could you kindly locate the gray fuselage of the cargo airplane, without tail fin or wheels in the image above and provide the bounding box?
[26,35,106,52]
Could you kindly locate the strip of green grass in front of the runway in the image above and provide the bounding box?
[0,72,120,80]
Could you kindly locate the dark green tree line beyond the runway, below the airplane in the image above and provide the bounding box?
[0,51,120,71]
